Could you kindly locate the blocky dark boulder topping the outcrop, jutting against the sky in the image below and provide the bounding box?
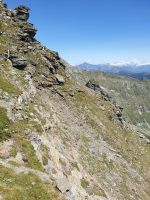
[13,6,30,21]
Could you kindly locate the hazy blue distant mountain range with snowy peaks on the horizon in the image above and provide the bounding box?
[77,62,150,79]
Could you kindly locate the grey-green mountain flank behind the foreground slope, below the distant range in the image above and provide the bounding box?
[67,67,150,138]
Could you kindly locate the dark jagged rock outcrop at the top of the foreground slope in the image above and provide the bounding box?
[1,0,65,88]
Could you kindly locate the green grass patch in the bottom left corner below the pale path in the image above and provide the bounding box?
[0,165,62,200]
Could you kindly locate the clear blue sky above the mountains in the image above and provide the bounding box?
[5,0,150,64]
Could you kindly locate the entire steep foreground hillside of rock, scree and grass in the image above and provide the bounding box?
[0,2,150,200]
